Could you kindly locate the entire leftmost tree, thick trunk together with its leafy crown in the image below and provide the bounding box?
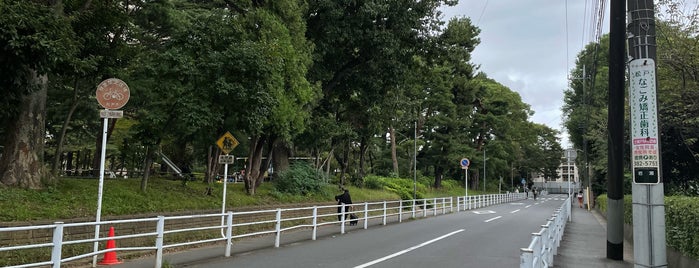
[0,1,75,188]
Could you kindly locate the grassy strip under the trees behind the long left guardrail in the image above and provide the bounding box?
[0,178,410,222]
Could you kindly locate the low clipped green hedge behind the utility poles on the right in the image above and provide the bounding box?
[595,195,699,258]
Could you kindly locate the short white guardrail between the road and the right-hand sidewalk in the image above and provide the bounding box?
[519,197,571,268]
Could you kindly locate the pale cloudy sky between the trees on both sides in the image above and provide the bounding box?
[442,0,609,148]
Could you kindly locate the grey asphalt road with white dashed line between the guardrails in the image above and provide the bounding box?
[187,195,564,268]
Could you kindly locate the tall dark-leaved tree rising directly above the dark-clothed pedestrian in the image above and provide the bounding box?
[306,0,456,183]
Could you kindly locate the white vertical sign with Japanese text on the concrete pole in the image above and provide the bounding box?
[629,59,660,184]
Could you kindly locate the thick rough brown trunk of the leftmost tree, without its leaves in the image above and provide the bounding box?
[0,72,51,189]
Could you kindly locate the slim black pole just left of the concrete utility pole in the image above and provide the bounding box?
[607,0,632,260]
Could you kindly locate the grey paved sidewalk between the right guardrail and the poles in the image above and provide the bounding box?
[553,205,633,268]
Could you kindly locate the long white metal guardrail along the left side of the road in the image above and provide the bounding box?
[0,193,524,268]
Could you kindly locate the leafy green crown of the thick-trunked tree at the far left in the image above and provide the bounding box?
[0,1,76,129]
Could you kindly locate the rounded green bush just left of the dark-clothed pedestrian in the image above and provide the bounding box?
[274,162,325,195]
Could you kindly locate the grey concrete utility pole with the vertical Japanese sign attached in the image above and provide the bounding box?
[627,0,667,268]
